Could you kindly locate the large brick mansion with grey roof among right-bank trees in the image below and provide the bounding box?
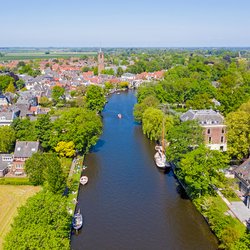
[180,109,227,151]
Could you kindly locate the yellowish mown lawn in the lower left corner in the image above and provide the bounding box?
[0,185,41,250]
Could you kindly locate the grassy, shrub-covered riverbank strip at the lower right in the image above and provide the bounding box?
[172,163,249,250]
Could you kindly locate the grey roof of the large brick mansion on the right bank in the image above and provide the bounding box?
[180,109,224,125]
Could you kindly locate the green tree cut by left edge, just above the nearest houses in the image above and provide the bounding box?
[0,126,16,153]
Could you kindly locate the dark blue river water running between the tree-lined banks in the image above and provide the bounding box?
[71,91,217,250]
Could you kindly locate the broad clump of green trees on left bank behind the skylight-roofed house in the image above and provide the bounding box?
[12,108,102,152]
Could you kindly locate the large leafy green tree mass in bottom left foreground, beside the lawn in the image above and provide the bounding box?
[4,192,70,250]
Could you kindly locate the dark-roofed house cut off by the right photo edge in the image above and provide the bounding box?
[234,158,250,208]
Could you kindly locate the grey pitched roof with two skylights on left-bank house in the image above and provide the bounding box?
[14,141,39,158]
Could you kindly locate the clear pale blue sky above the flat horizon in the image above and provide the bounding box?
[0,0,250,47]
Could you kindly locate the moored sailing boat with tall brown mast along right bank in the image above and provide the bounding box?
[154,116,170,169]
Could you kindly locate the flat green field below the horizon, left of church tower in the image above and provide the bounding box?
[0,51,97,62]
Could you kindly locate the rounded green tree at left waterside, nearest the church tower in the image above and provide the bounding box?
[85,85,106,112]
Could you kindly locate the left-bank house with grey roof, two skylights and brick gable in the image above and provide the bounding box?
[11,141,41,175]
